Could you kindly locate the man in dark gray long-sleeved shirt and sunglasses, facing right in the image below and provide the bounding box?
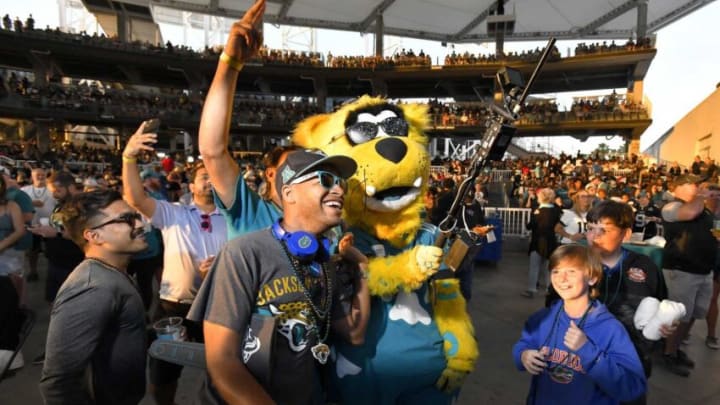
[40,190,147,405]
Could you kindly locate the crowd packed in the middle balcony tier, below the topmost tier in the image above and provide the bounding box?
[0,72,648,128]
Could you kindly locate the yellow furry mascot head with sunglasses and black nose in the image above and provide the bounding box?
[293,96,430,248]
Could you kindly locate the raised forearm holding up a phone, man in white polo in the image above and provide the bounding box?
[122,122,157,218]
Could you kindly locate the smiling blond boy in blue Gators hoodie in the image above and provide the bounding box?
[513,245,647,404]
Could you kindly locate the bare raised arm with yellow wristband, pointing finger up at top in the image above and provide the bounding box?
[198,0,265,207]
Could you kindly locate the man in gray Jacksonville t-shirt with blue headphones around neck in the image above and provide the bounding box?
[188,150,370,404]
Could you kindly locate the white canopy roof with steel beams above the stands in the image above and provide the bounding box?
[83,0,713,43]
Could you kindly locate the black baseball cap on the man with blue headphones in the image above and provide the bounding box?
[275,149,357,195]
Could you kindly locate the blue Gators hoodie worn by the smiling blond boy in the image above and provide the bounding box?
[513,301,647,404]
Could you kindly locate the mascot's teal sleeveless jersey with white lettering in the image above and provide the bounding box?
[333,224,452,405]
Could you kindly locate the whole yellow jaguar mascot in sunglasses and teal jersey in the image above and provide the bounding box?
[293,96,478,404]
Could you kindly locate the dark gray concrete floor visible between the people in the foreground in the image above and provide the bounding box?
[0,240,720,405]
